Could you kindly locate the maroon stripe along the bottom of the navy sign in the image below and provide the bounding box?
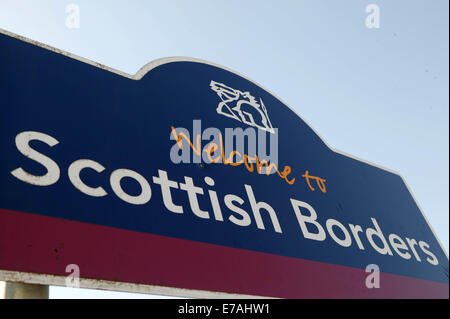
[0,209,449,298]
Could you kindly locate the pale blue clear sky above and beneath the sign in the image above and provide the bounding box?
[0,0,449,298]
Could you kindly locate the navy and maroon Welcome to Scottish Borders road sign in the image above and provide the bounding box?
[0,31,448,298]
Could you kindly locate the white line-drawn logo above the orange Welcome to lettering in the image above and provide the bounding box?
[209,81,275,134]
